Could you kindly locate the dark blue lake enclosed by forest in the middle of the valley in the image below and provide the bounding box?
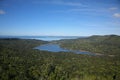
[34,44,93,55]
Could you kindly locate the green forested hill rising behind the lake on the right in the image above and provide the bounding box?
[57,35,120,55]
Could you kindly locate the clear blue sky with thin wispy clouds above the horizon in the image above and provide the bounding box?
[0,0,120,36]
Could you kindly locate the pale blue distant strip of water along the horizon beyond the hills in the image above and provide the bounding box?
[0,36,84,41]
